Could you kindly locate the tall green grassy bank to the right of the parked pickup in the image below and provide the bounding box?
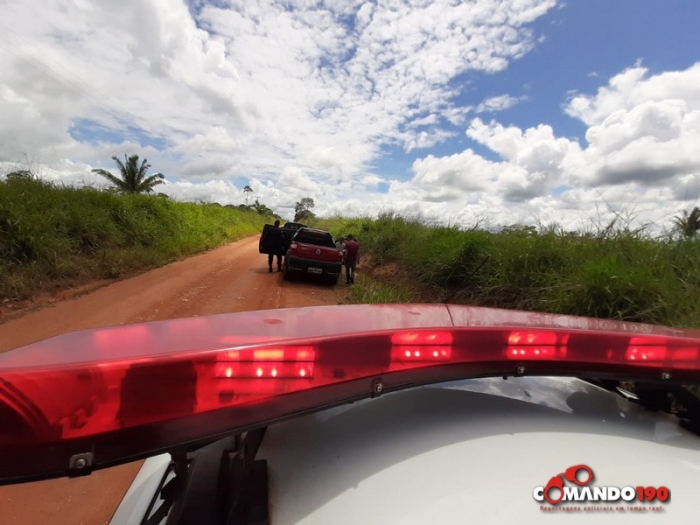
[314,214,700,328]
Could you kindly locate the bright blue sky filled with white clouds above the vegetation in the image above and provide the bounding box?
[0,0,700,228]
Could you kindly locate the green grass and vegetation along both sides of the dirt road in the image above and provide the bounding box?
[5,167,700,327]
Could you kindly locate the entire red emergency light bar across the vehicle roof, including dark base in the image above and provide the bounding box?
[0,305,700,483]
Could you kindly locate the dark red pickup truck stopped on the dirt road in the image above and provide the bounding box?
[284,228,343,284]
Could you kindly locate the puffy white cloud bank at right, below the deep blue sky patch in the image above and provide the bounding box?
[404,64,700,229]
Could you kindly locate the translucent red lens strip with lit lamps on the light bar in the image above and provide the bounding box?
[5,328,700,444]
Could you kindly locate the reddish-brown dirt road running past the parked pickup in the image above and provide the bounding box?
[0,238,342,525]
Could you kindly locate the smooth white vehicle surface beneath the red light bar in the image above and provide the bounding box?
[258,378,700,525]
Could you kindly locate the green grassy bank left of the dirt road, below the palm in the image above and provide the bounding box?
[0,179,270,302]
